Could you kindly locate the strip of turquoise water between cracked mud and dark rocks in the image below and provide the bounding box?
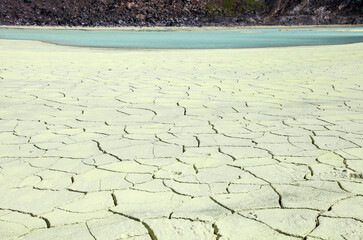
[0,27,363,49]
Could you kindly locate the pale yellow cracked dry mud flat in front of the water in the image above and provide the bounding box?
[0,40,363,240]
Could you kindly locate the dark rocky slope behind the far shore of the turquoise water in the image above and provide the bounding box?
[0,0,363,26]
